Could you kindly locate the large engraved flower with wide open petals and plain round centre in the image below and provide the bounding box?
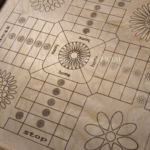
[84,111,139,150]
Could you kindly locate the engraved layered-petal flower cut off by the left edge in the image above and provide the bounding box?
[0,69,17,109]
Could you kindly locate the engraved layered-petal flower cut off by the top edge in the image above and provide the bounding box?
[30,0,65,12]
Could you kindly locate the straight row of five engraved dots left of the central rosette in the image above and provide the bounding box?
[8,33,51,50]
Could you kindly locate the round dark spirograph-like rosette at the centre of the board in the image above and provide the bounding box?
[58,42,90,70]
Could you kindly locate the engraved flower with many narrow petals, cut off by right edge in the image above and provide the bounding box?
[130,4,150,42]
